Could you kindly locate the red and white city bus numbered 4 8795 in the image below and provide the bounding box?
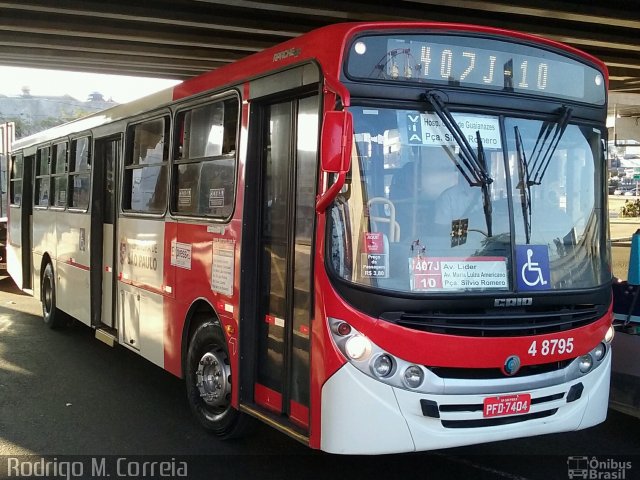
[8,22,612,454]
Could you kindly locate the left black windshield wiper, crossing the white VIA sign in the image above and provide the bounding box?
[422,91,493,237]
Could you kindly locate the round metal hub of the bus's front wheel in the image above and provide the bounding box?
[196,352,231,407]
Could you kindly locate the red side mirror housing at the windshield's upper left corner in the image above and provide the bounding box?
[320,110,353,173]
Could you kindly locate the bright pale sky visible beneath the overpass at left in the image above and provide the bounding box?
[0,66,180,103]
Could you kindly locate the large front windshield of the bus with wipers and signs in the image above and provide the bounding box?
[329,107,607,295]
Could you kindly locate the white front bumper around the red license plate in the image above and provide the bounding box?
[320,351,611,454]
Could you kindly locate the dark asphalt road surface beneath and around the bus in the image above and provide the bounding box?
[0,278,640,480]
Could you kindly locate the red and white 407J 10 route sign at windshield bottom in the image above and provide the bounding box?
[409,257,509,292]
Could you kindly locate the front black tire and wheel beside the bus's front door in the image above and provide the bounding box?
[185,319,250,439]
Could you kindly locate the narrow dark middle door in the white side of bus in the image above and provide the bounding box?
[91,136,122,329]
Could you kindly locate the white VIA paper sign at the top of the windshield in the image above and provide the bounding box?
[398,112,502,149]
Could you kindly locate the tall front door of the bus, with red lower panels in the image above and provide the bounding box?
[250,94,319,430]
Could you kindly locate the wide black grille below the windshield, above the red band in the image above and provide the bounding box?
[381,305,606,337]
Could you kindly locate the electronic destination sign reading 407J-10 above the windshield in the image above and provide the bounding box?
[347,34,605,105]
